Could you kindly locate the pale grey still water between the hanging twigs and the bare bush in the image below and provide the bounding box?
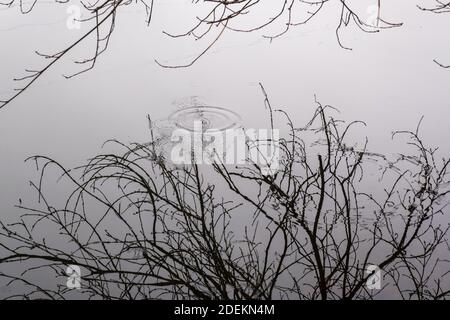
[0,0,450,296]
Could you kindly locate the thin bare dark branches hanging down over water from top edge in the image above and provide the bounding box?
[0,0,402,109]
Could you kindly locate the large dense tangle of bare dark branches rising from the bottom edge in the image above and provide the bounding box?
[0,90,450,299]
